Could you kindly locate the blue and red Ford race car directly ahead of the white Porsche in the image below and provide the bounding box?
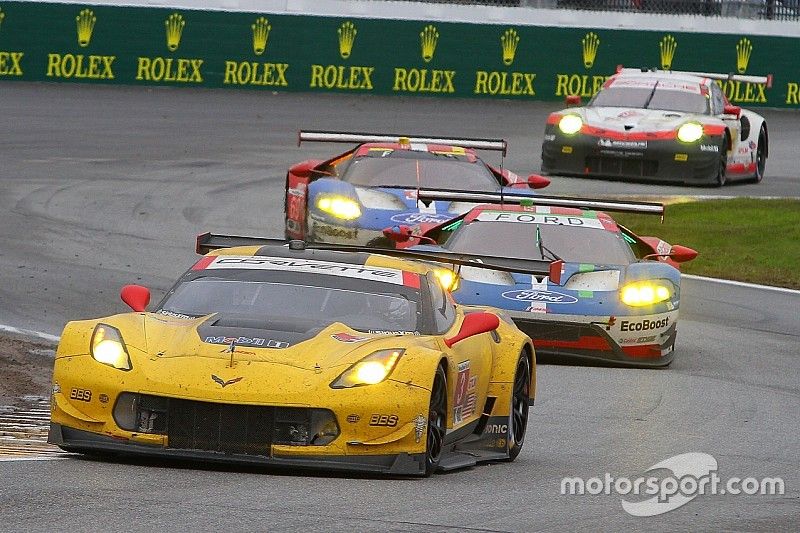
[284,131,550,246]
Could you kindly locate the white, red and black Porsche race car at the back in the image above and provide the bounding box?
[542,68,771,186]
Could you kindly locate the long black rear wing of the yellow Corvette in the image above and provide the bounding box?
[195,233,563,283]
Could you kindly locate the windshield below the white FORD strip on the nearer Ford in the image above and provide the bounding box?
[445,221,634,265]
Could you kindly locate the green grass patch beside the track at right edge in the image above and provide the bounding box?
[614,198,800,289]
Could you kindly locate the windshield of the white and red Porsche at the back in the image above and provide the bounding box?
[589,86,708,114]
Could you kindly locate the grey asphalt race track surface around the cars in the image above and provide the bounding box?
[0,83,800,531]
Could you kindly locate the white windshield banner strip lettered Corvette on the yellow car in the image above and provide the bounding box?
[200,255,404,285]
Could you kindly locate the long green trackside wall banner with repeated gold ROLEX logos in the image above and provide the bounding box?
[0,0,800,107]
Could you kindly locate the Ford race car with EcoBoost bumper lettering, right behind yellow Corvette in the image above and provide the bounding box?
[387,191,697,366]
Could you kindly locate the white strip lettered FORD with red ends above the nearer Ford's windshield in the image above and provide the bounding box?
[464,205,620,233]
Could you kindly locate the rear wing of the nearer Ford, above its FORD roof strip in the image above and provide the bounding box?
[417,189,664,219]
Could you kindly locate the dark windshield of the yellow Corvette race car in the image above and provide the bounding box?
[160,277,418,331]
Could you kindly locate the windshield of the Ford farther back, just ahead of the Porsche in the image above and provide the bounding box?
[342,150,500,192]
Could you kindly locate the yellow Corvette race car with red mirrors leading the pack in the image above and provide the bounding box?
[49,234,536,475]
